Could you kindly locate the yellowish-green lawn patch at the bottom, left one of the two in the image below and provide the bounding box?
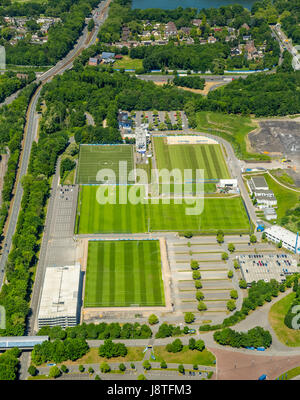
[60,346,145,365]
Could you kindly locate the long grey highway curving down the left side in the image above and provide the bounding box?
[0,0,111,289]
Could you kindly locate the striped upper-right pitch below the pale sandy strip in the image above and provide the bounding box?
[154,137,230,179]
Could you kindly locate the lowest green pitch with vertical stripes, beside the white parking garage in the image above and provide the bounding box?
[84,240,165,307]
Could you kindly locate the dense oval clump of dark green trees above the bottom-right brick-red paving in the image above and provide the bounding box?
[214,326,272,348]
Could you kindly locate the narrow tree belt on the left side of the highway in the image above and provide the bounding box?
[0,83,37,236]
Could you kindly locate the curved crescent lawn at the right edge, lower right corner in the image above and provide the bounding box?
[269,293,300,347]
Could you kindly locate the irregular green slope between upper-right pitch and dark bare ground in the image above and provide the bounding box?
[196,111,269,160]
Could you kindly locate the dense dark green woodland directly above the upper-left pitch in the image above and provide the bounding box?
[37,68,196,143]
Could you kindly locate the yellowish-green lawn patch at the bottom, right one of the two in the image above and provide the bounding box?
[150,346,216,366]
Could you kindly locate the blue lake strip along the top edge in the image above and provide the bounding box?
[132,0,255,10]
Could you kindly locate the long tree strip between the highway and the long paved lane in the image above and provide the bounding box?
[0,86,68,336]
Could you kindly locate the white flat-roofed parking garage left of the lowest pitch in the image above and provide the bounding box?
[38,264,81,329]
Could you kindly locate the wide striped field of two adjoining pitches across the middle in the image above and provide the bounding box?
[75,185,249,234]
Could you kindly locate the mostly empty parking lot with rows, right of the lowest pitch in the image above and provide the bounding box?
[167,235,286,324]
